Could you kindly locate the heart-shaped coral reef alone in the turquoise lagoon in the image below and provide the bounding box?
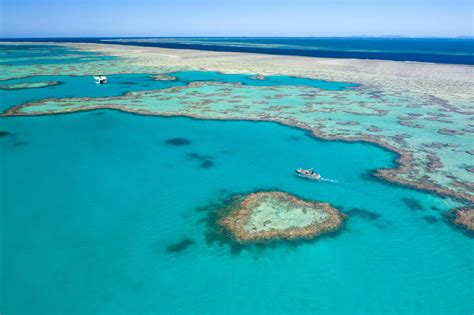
[217,191,344,243]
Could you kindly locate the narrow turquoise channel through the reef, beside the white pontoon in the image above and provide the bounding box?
[0,71,355,109]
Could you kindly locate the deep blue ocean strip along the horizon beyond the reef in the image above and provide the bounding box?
[1,37,474,65]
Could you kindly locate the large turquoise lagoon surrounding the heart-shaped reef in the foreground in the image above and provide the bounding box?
[0,110,474,314]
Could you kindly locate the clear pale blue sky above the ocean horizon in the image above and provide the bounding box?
[0,0,474,37]
